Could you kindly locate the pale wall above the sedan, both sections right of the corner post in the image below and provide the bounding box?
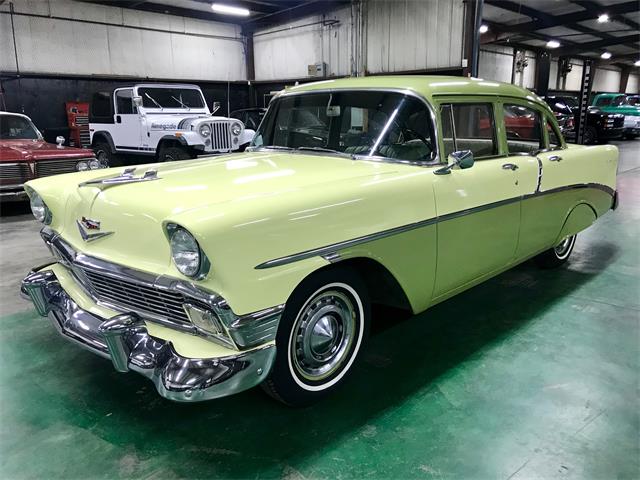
[254,0,464,81]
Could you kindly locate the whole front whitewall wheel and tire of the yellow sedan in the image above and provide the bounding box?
[262,267,371,406]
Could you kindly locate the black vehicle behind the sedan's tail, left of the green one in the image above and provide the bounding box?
[545,95,624,145]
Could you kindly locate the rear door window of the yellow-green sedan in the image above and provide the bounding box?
[503,104,544,153]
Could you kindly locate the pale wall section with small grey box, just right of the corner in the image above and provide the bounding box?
[253,7,351,80]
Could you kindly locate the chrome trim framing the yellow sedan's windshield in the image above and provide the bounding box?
[256,87,446,167]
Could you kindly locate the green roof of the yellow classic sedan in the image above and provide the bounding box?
[281,75,545,105]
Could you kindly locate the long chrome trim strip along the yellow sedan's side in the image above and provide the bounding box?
[254,183,615,270]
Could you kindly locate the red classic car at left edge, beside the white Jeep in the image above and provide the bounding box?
[0,112,107,201]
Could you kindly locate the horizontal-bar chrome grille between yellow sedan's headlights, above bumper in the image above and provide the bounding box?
[75,266,191,325]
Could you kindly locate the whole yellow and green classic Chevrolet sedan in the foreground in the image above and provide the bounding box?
[22,76,618,405]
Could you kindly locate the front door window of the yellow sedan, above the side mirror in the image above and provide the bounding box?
[441,103,498,158]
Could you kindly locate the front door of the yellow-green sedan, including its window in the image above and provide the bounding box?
[434,97,520,300]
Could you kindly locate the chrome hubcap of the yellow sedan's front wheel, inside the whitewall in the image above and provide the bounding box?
[291,290,356,381]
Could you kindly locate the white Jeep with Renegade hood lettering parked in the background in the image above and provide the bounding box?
[89,83,255,166]
